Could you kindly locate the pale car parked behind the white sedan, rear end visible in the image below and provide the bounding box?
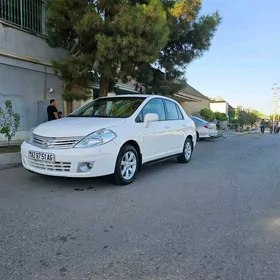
[190,116,218,140]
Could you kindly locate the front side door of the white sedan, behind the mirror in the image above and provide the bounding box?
[136,98,168,163]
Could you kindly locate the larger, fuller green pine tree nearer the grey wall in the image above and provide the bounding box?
[46,0,169,111]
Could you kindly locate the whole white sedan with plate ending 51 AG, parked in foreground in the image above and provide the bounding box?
[21,94,196,185]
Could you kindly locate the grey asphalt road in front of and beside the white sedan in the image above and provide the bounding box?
[0,135,280,280]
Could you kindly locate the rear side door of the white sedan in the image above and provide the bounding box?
[164,99,186,156]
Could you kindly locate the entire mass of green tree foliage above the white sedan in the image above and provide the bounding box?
[46,0,221,101]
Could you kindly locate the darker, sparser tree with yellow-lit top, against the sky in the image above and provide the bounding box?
[137,0,221,94]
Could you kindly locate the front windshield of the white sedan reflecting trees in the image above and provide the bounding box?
[69,97,145,118]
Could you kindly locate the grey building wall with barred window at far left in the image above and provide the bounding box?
[0,0,65,141]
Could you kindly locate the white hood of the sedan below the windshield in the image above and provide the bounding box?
[33,117,125,137]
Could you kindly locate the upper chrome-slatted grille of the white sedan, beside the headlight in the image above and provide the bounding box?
[32,134,82,149]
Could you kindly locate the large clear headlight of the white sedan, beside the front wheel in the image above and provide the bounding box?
[74,129,117,148]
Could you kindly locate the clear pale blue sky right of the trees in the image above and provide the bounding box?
[186,0,280,114]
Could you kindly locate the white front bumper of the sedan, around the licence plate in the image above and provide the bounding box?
[21,141,119,178]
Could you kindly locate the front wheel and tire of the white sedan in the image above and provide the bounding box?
[114,145,139,186]
